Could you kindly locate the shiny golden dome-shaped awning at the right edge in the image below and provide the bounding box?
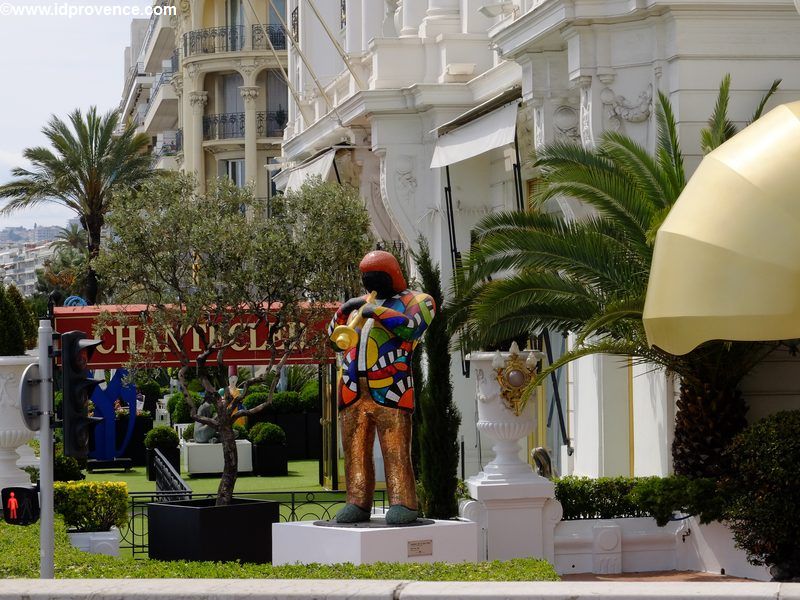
[644,102,800,354]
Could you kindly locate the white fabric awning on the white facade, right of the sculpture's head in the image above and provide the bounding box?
[431,102,517,169]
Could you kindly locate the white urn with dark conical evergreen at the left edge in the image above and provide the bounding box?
[0,284,37,487]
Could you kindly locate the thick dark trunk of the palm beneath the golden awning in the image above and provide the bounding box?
[672,380,748,479]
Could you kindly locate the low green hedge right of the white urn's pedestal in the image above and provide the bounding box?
[555,476,724,526]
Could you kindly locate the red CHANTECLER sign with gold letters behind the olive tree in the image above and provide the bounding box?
[53,305,336,369]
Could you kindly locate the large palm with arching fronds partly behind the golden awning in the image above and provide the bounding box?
[456,77,777,476]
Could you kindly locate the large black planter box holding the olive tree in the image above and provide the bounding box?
[147,498,280,563]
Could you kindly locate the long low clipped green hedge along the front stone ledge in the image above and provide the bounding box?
[0,516,558,581]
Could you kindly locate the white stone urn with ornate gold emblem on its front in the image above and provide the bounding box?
[468,342,543,483]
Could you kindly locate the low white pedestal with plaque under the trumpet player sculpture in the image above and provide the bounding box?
[272,521,478,565]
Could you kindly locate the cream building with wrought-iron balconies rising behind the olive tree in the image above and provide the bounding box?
[120,0,288,202]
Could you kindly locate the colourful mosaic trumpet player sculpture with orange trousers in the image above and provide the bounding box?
[328,250,436,525]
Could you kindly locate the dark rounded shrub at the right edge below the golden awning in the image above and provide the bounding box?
[724,411,800,581]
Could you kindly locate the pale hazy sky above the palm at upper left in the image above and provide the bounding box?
[0,0,150,229]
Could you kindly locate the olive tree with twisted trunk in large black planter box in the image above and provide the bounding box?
[97,174,371,561]
